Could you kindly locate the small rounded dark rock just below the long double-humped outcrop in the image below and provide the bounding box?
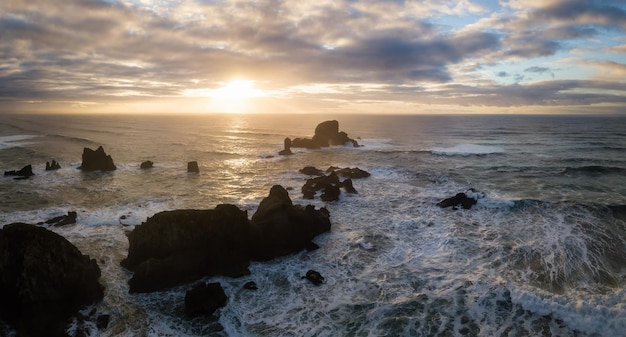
[185,282,228,317]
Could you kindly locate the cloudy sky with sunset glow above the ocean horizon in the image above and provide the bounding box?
[0,0,626,114]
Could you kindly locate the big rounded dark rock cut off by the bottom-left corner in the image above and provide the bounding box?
[0,223,104,337]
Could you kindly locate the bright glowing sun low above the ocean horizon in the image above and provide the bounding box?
[209,79,264,113]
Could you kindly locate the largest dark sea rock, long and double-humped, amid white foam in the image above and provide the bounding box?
[122,185,330,292]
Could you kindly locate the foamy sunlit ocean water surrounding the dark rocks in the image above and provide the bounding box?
[0,115,626,337]
